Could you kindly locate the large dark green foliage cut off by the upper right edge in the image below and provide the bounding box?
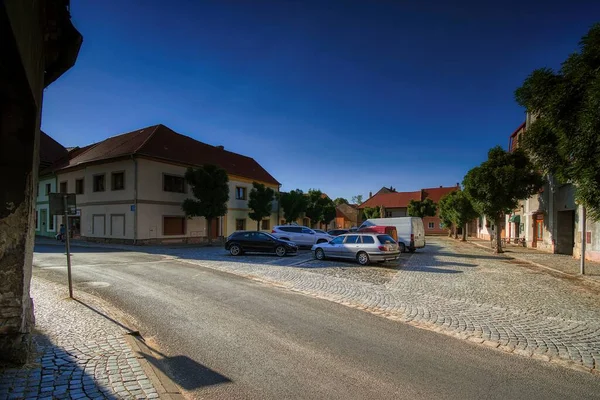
[515,24,600,221]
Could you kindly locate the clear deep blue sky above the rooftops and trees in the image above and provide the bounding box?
[42,0,600,198]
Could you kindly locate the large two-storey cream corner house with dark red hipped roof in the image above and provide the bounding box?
[43,125,280,244]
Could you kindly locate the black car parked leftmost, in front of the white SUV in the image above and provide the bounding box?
[225,231,298,257]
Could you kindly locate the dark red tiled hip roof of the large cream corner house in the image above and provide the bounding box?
[52,124,279,185]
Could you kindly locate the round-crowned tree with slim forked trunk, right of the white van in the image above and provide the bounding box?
[463,146,543,253]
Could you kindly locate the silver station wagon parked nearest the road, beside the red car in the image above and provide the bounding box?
[312,232,400,265]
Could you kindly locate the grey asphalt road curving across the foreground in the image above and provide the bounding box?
[34,246,600,400]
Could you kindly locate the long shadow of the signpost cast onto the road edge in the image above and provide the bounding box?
[74,299,232,390]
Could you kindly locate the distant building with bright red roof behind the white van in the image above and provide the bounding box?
[358,184,460,235]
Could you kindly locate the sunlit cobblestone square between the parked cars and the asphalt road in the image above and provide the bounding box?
[175,238,600,372]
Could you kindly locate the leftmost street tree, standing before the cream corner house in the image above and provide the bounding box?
[181,164,229,244]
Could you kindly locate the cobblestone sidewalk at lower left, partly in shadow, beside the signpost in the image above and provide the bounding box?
[0,277,159,399]
